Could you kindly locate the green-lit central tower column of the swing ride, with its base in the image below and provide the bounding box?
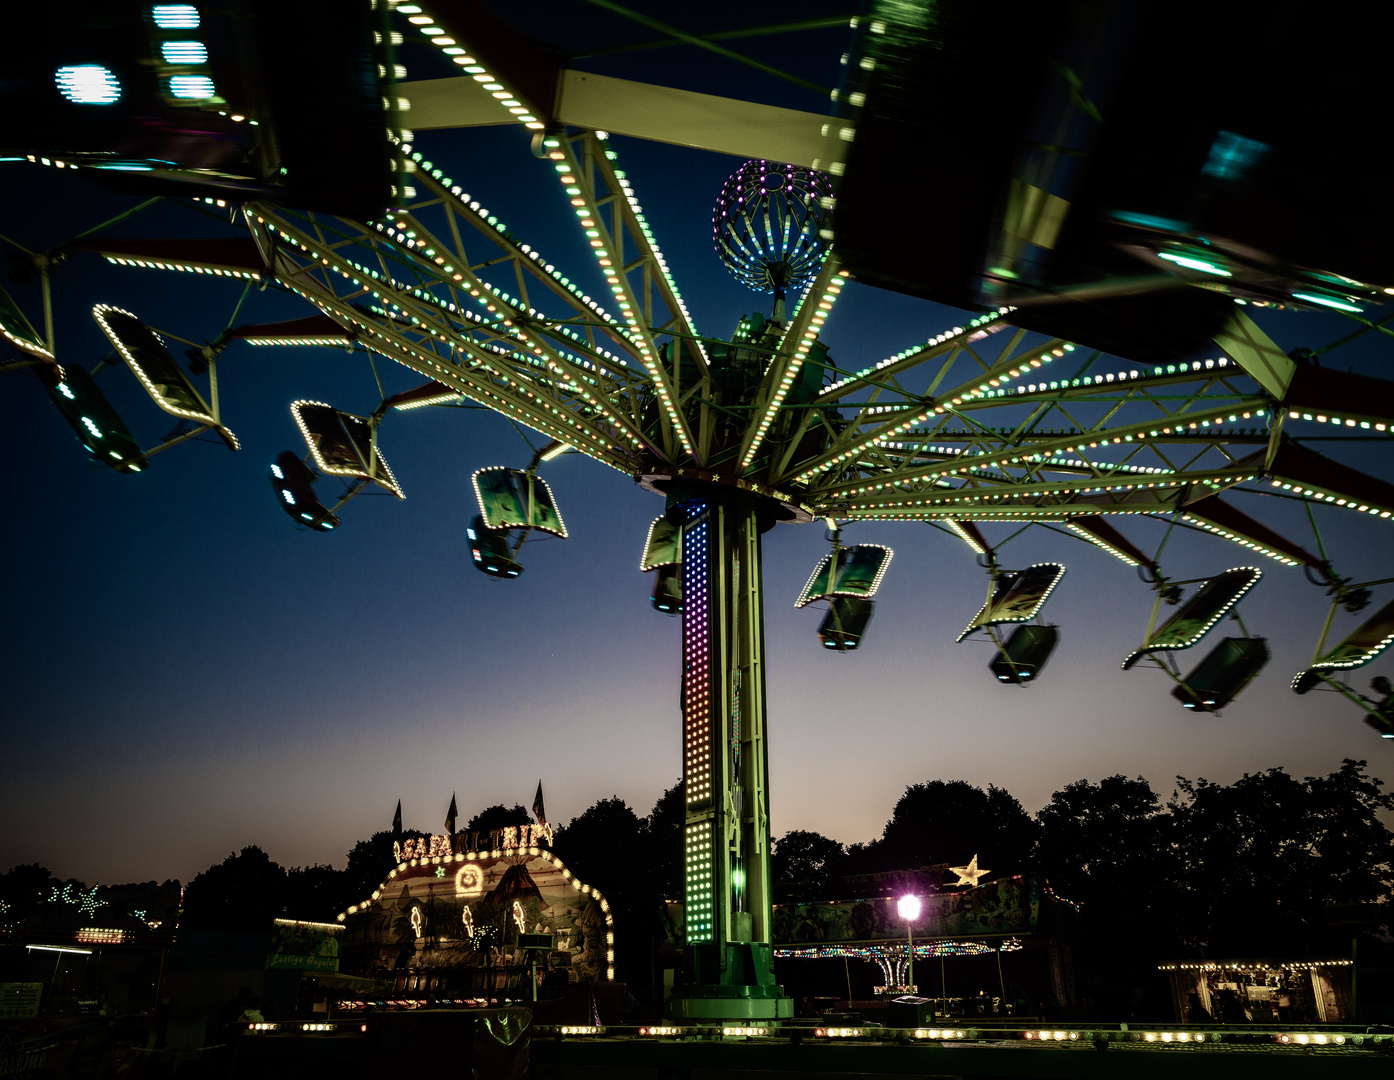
[669,485,793,1020]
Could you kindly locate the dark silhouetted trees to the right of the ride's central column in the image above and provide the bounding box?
[772,759,1394,1002]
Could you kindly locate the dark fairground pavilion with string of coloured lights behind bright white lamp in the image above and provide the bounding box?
[774,874,1075,1016]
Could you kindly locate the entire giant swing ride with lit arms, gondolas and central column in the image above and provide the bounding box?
[0,3,1394,1019]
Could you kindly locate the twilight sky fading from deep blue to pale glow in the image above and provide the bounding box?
[0,3,1394,884]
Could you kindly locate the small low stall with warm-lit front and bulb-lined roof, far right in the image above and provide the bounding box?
[1160,956,1354,1024]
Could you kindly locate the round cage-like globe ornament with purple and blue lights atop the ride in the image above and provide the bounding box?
[711,160,832,319]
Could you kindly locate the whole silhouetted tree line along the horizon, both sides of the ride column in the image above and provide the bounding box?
[8,759,1394,1001]
